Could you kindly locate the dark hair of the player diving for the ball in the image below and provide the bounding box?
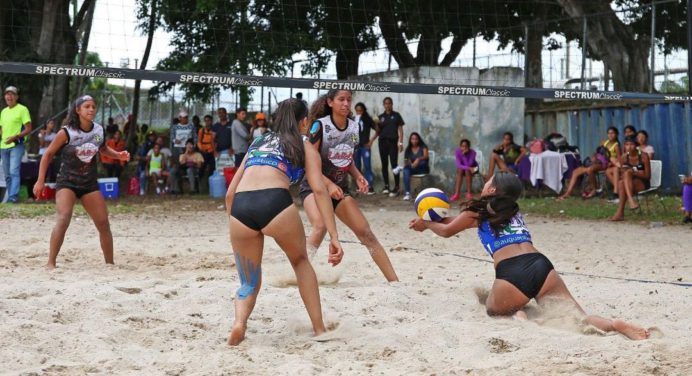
[462,171,524,236]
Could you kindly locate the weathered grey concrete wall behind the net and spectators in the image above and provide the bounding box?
[353,67,524,191]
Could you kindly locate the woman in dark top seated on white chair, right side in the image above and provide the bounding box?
[610,137,651,221]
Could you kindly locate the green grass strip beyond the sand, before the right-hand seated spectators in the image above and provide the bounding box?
[519,196,682,224]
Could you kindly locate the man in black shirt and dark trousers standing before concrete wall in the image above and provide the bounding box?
[373,97,405,197]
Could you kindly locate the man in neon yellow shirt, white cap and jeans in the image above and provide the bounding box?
[0,86,31,203]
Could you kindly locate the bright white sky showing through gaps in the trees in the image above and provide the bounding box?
[89,0,687,108]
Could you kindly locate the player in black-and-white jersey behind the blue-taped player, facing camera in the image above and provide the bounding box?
[300,90,398,282]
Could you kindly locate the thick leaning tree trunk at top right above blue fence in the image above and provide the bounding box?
[557,0,650,92]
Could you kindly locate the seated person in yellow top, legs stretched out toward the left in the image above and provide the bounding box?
[557,127,620,201]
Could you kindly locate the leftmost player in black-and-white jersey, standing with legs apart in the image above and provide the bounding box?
[34,95,130,269]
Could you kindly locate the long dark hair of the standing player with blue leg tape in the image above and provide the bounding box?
[272,98,308,166]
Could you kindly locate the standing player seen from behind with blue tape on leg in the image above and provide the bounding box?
[226,99,343,346]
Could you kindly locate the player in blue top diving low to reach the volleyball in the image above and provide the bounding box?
[409,172,649,340]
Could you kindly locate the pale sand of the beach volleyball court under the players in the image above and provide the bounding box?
[0,203,692,375]
